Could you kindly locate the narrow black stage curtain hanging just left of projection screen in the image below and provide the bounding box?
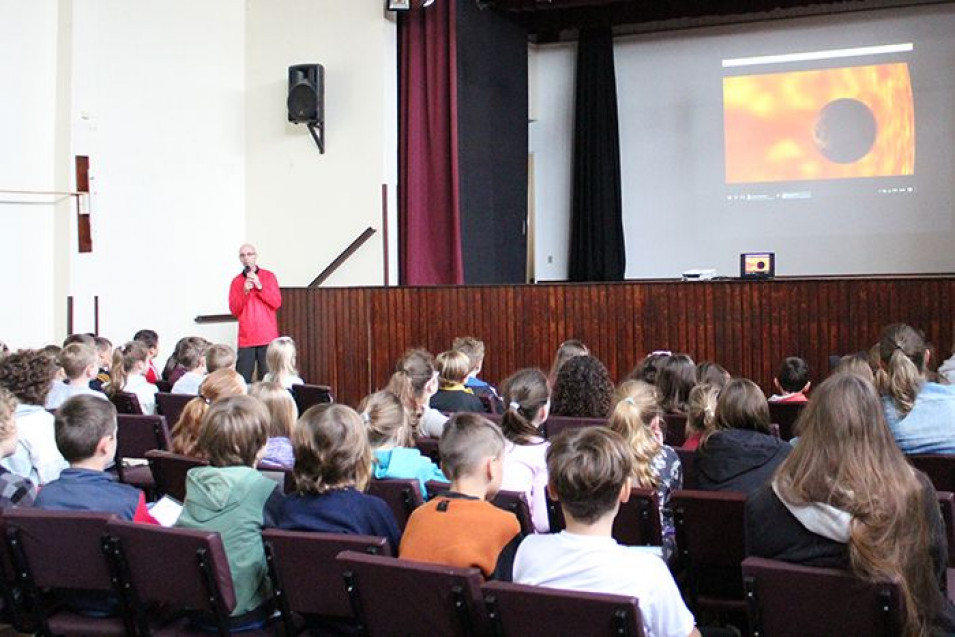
[569,27,626,281]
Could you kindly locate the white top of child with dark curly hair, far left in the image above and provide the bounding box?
[2,405,69,486]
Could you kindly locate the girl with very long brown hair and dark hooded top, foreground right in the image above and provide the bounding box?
[746,372,955,635]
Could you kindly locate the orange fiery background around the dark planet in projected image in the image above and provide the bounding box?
[723,63,915,184]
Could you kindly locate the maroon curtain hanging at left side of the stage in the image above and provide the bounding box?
[398,0,464,285]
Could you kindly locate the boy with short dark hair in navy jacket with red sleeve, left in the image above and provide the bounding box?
[36,395,157,524]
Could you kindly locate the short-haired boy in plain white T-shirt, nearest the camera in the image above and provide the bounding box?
[514,427,700,637]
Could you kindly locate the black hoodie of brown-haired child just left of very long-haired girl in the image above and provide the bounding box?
[694,429,792,493]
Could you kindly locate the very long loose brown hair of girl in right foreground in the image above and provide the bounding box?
[775,374,941,635]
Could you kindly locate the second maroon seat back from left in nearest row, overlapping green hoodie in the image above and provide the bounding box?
[107,519,235,615]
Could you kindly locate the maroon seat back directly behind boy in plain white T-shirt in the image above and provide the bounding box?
[481,582,645,637]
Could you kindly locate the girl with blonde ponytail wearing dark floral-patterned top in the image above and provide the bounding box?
[608,383,683,561]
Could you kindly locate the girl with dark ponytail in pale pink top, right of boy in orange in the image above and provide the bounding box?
[501,363,548,533]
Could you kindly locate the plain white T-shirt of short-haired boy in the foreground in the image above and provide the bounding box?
[514,531,695,637]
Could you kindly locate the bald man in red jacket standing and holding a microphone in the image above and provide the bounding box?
[229,243,282,383]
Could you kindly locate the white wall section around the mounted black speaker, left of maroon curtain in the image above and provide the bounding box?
[245,0,397,286]
